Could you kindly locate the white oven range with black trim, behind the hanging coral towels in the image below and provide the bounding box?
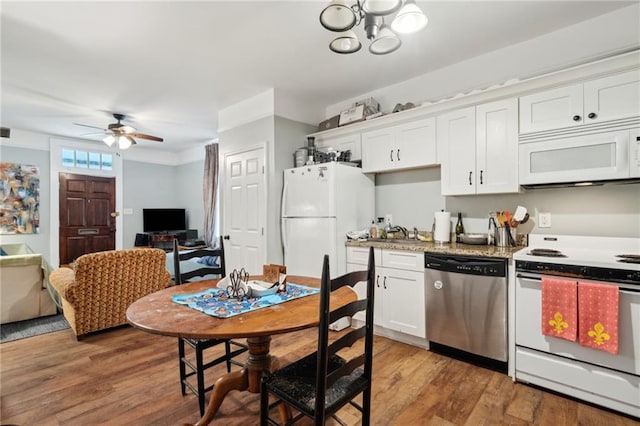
[513,234,640,418]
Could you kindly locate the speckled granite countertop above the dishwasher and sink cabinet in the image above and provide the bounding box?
[345,239,524,259]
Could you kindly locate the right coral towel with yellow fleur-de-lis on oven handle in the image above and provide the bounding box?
[578,282,620,355]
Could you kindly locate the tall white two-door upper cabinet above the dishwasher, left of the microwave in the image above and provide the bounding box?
[438,98,519,195]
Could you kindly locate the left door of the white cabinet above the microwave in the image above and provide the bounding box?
[520,84,584,133]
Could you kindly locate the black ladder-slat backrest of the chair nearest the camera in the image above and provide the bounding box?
[315,247,375,424]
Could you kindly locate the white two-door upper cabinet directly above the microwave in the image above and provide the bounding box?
[520,70,640,133]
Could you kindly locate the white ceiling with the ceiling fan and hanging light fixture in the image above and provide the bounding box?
[0,0,630,151]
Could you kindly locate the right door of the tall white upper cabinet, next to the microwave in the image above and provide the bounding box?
[475,98,520,194]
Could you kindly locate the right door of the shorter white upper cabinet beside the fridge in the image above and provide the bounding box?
[396,117,437,169]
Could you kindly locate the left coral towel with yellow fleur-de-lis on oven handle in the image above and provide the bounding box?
[542,276,578,342]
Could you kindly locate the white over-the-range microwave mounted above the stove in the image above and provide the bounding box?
[519,128,640,187]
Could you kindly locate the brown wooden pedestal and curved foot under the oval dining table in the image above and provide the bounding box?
[188,336,278,426]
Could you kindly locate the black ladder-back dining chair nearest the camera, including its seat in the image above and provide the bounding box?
[260,248,375,426]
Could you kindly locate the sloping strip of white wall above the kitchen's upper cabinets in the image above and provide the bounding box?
[326,3,640,117]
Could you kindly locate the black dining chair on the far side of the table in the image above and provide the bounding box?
[173,237,247,416]
